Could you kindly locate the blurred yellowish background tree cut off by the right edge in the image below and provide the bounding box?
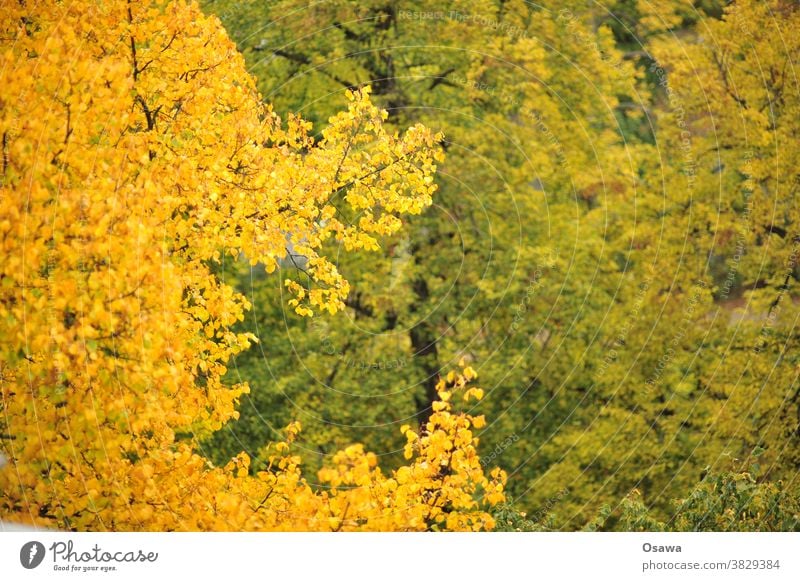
[640,0,800,490]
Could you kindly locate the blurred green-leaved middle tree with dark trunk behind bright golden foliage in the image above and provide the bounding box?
[202,2,646,512]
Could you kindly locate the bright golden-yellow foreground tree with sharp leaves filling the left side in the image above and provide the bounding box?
[0,0,504,530]
